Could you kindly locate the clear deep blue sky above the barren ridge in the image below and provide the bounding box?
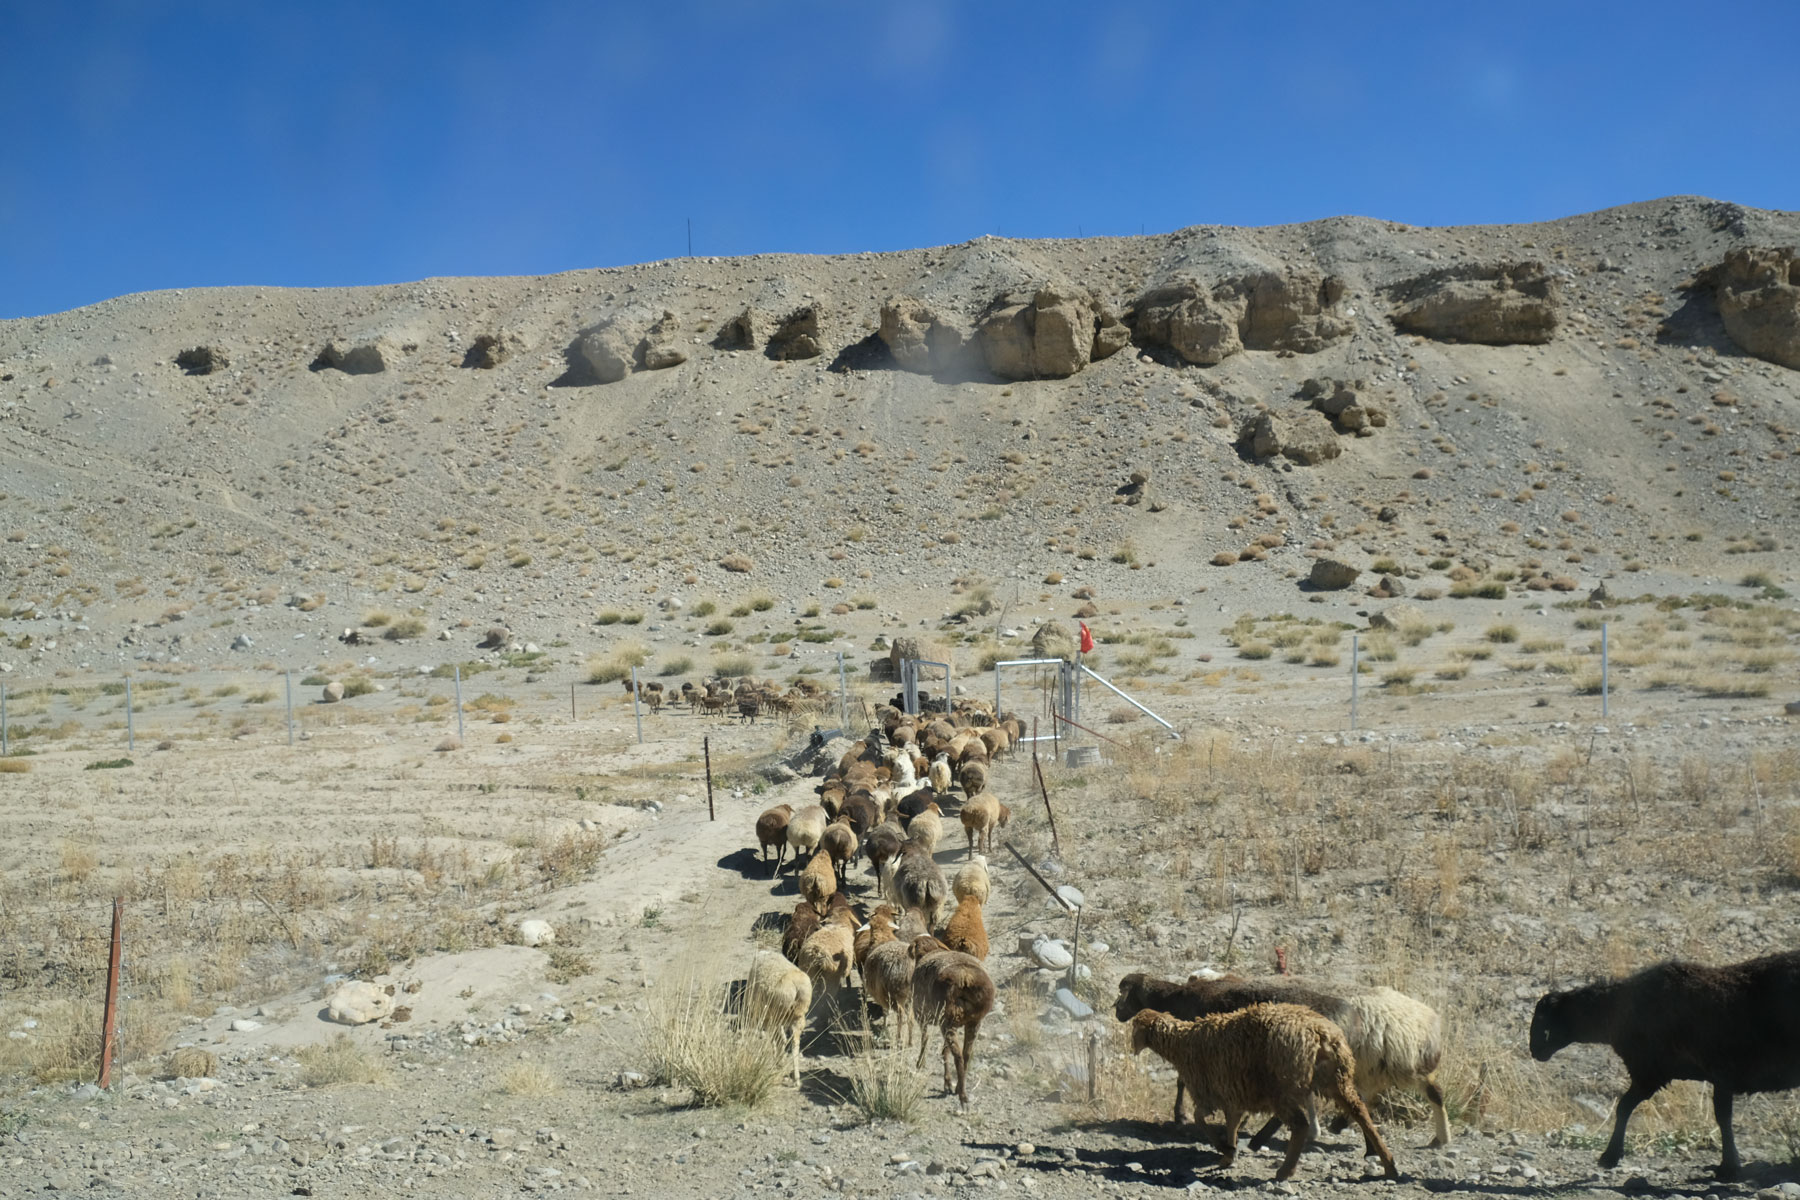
[0,0,1800,317]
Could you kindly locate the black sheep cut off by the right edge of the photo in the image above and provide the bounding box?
[1532,950,1800,1180]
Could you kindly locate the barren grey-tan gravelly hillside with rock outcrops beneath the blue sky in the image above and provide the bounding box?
[0,198,1800,671]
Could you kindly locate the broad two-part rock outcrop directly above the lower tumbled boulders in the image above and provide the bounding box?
[1132,270,1354,367]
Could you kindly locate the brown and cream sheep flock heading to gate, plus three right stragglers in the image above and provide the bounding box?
[716,700,1800,1180]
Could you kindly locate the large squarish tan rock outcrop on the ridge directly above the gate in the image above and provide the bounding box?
[976,282,1129,380]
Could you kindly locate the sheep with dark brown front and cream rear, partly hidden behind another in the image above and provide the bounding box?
[1112,973,1451,1153]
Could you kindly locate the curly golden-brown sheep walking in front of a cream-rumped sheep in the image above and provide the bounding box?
[1130,1004,1400,1180]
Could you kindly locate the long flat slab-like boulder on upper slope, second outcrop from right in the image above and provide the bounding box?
[1393,261,1561,345]
